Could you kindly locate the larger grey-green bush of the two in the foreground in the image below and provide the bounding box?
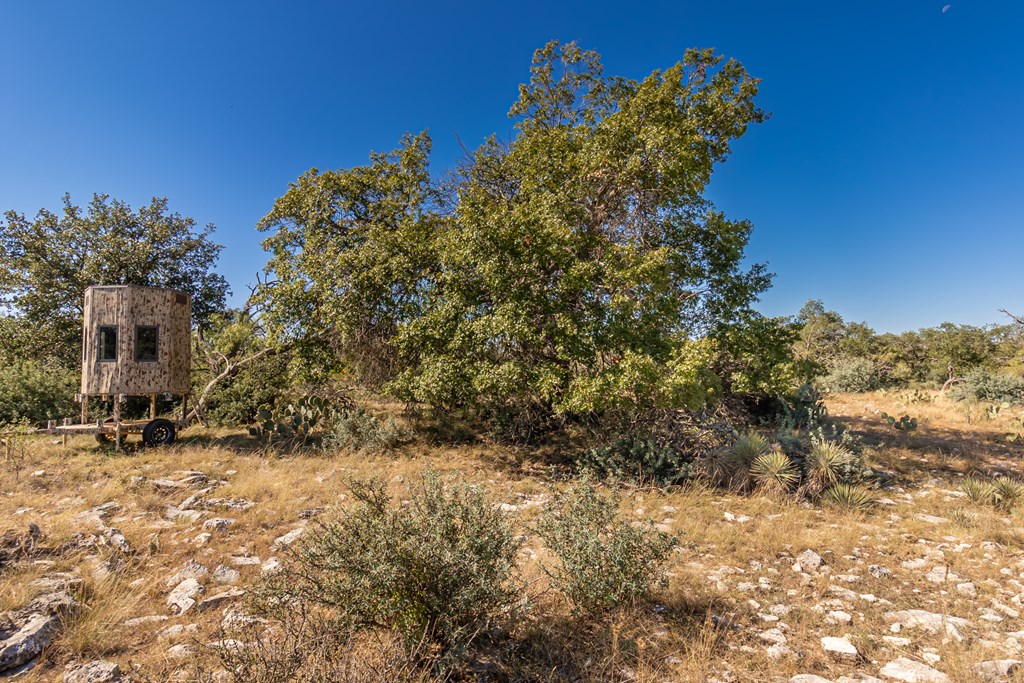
[261,473,520,668]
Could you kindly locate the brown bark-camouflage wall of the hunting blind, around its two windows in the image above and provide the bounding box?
[82,286,191,395]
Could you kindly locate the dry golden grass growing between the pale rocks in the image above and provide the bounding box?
[0,393,1024,682]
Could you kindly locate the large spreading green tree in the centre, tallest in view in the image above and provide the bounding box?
[260,43,770,435]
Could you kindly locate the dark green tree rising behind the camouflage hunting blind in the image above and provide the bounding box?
[0,195,228,366]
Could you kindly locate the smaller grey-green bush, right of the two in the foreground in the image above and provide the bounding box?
[538,479,676,617]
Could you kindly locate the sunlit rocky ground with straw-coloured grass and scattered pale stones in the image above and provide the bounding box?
[0,394,1024,683]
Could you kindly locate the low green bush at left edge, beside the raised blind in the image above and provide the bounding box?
[0,359,78,424]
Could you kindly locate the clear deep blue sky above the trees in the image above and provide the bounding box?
[0,0,1024,331]
